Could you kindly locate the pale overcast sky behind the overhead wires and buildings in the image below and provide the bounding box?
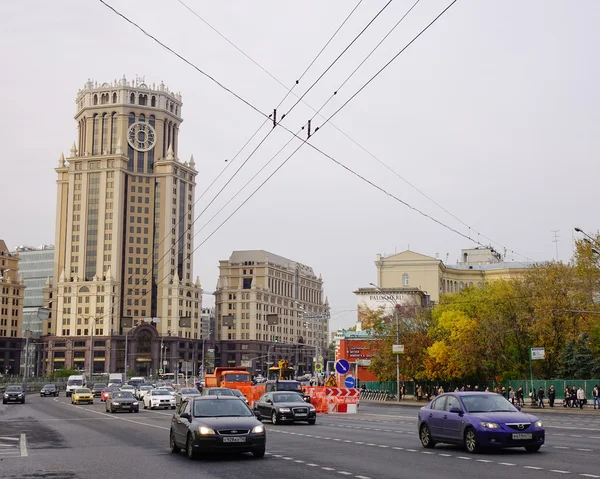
[0,0,600,330]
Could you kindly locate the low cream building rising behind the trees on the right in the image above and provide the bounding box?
[375,248,530,303]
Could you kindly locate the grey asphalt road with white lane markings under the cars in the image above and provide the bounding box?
[0,395,600,479]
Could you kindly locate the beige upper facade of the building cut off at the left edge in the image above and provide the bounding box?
[0,240,25,338]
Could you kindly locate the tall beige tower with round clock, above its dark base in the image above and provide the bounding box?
[44,77,201,376]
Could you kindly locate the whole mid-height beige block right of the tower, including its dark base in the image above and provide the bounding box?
[215,250,329,374]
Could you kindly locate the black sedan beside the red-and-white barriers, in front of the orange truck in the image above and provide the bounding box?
[254,391,317,424]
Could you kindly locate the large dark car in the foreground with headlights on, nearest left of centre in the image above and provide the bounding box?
[169,396,267,459]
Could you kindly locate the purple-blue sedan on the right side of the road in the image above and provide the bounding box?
[419,391,546,453]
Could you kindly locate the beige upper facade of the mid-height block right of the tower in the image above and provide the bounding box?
[215,250,329,351]
